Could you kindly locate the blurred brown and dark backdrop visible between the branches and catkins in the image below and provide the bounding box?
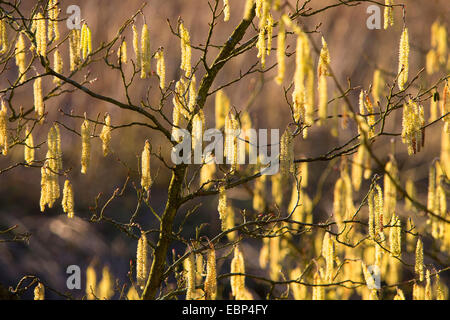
[0,0,450,298]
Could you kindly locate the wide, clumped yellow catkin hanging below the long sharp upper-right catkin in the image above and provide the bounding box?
[402,100,425,155]
